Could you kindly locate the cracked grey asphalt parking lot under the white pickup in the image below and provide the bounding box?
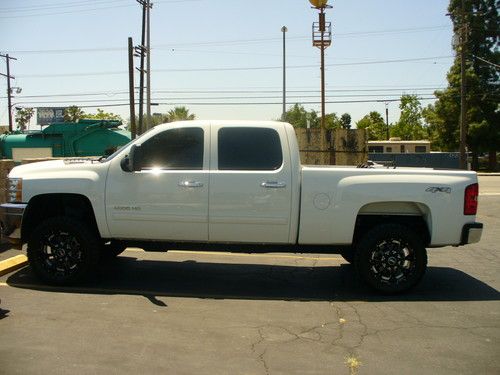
[0,176,500,375]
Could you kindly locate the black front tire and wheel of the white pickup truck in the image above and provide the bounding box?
[27,217,100,285]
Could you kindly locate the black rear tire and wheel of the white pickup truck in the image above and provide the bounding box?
[354,224,427,294]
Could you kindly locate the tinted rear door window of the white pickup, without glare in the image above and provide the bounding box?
[218,128,283,171]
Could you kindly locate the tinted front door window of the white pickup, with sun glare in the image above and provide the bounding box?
[141,128,203,169]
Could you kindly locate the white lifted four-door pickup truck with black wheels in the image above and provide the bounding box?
[0,121,483,293]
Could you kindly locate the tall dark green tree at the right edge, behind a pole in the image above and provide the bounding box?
[424,0,500,170]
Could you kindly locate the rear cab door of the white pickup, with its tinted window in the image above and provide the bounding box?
[209,124,292,244]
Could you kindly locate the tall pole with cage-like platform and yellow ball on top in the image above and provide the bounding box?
[309,0,332,129]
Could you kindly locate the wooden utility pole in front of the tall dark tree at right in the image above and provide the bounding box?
[460,0,467,169]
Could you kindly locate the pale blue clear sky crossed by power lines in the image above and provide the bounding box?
[0,0,453,127]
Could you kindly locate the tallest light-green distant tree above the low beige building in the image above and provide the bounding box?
[391,95,427,141]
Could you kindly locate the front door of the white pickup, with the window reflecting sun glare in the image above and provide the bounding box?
[106,125,210,241]
